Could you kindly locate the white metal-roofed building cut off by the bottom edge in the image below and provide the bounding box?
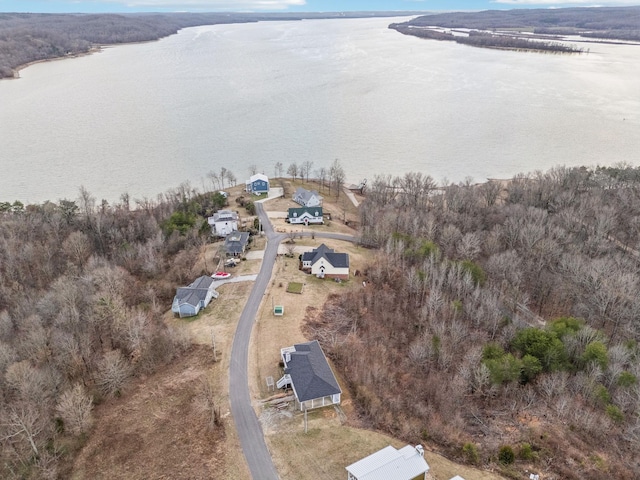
[346,445,429,480]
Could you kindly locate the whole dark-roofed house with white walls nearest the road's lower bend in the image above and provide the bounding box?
[277,340,342,411]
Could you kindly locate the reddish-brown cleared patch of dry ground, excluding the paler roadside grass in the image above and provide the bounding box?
[72,347,242,479]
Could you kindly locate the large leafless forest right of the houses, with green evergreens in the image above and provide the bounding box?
[306,165,640,480]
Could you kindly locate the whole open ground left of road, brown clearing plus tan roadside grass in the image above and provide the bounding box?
[72,272,254,480]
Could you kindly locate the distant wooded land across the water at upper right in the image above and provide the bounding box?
[389,7,640,52]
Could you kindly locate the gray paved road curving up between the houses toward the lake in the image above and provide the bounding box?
[229,203,357,480]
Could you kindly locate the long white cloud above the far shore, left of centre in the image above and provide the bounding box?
[102,0,307,12]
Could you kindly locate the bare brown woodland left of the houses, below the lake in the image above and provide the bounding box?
[0,184,226,479]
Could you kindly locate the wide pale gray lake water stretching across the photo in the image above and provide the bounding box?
[0,18,640,202]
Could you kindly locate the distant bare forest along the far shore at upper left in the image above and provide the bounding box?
[0,12,420,78]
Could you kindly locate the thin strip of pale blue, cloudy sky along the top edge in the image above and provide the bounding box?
[0,0,640,13]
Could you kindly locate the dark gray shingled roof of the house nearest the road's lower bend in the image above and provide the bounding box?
[285,340,342,402]
